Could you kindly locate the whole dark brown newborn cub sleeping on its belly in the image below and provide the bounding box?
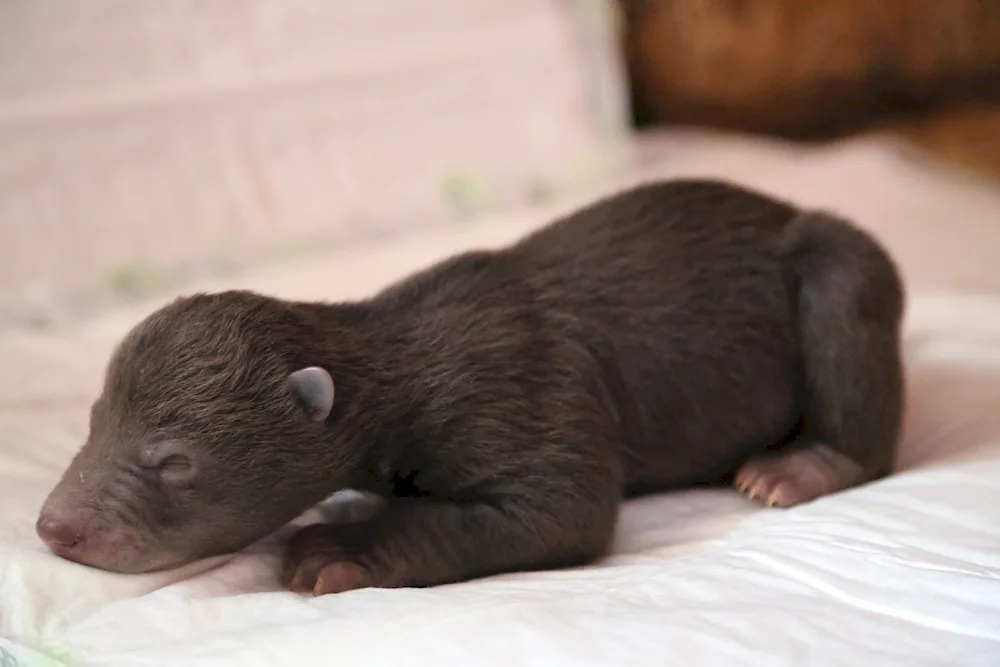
[36,180,904,595]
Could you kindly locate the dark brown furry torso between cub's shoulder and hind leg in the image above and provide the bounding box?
[511,181,800,488]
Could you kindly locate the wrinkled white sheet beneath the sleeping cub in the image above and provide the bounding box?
[0,294,1000,667]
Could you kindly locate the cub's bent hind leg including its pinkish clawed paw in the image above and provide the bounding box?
[735,213,904,507]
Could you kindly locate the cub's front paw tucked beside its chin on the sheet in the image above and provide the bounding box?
[282,523,375,595]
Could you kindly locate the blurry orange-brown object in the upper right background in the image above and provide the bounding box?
[618,0,1000,176]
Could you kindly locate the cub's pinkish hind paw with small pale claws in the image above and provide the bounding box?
[734,444,862,507]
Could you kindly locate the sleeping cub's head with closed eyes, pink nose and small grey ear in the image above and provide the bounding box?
[36,292,352,572]
